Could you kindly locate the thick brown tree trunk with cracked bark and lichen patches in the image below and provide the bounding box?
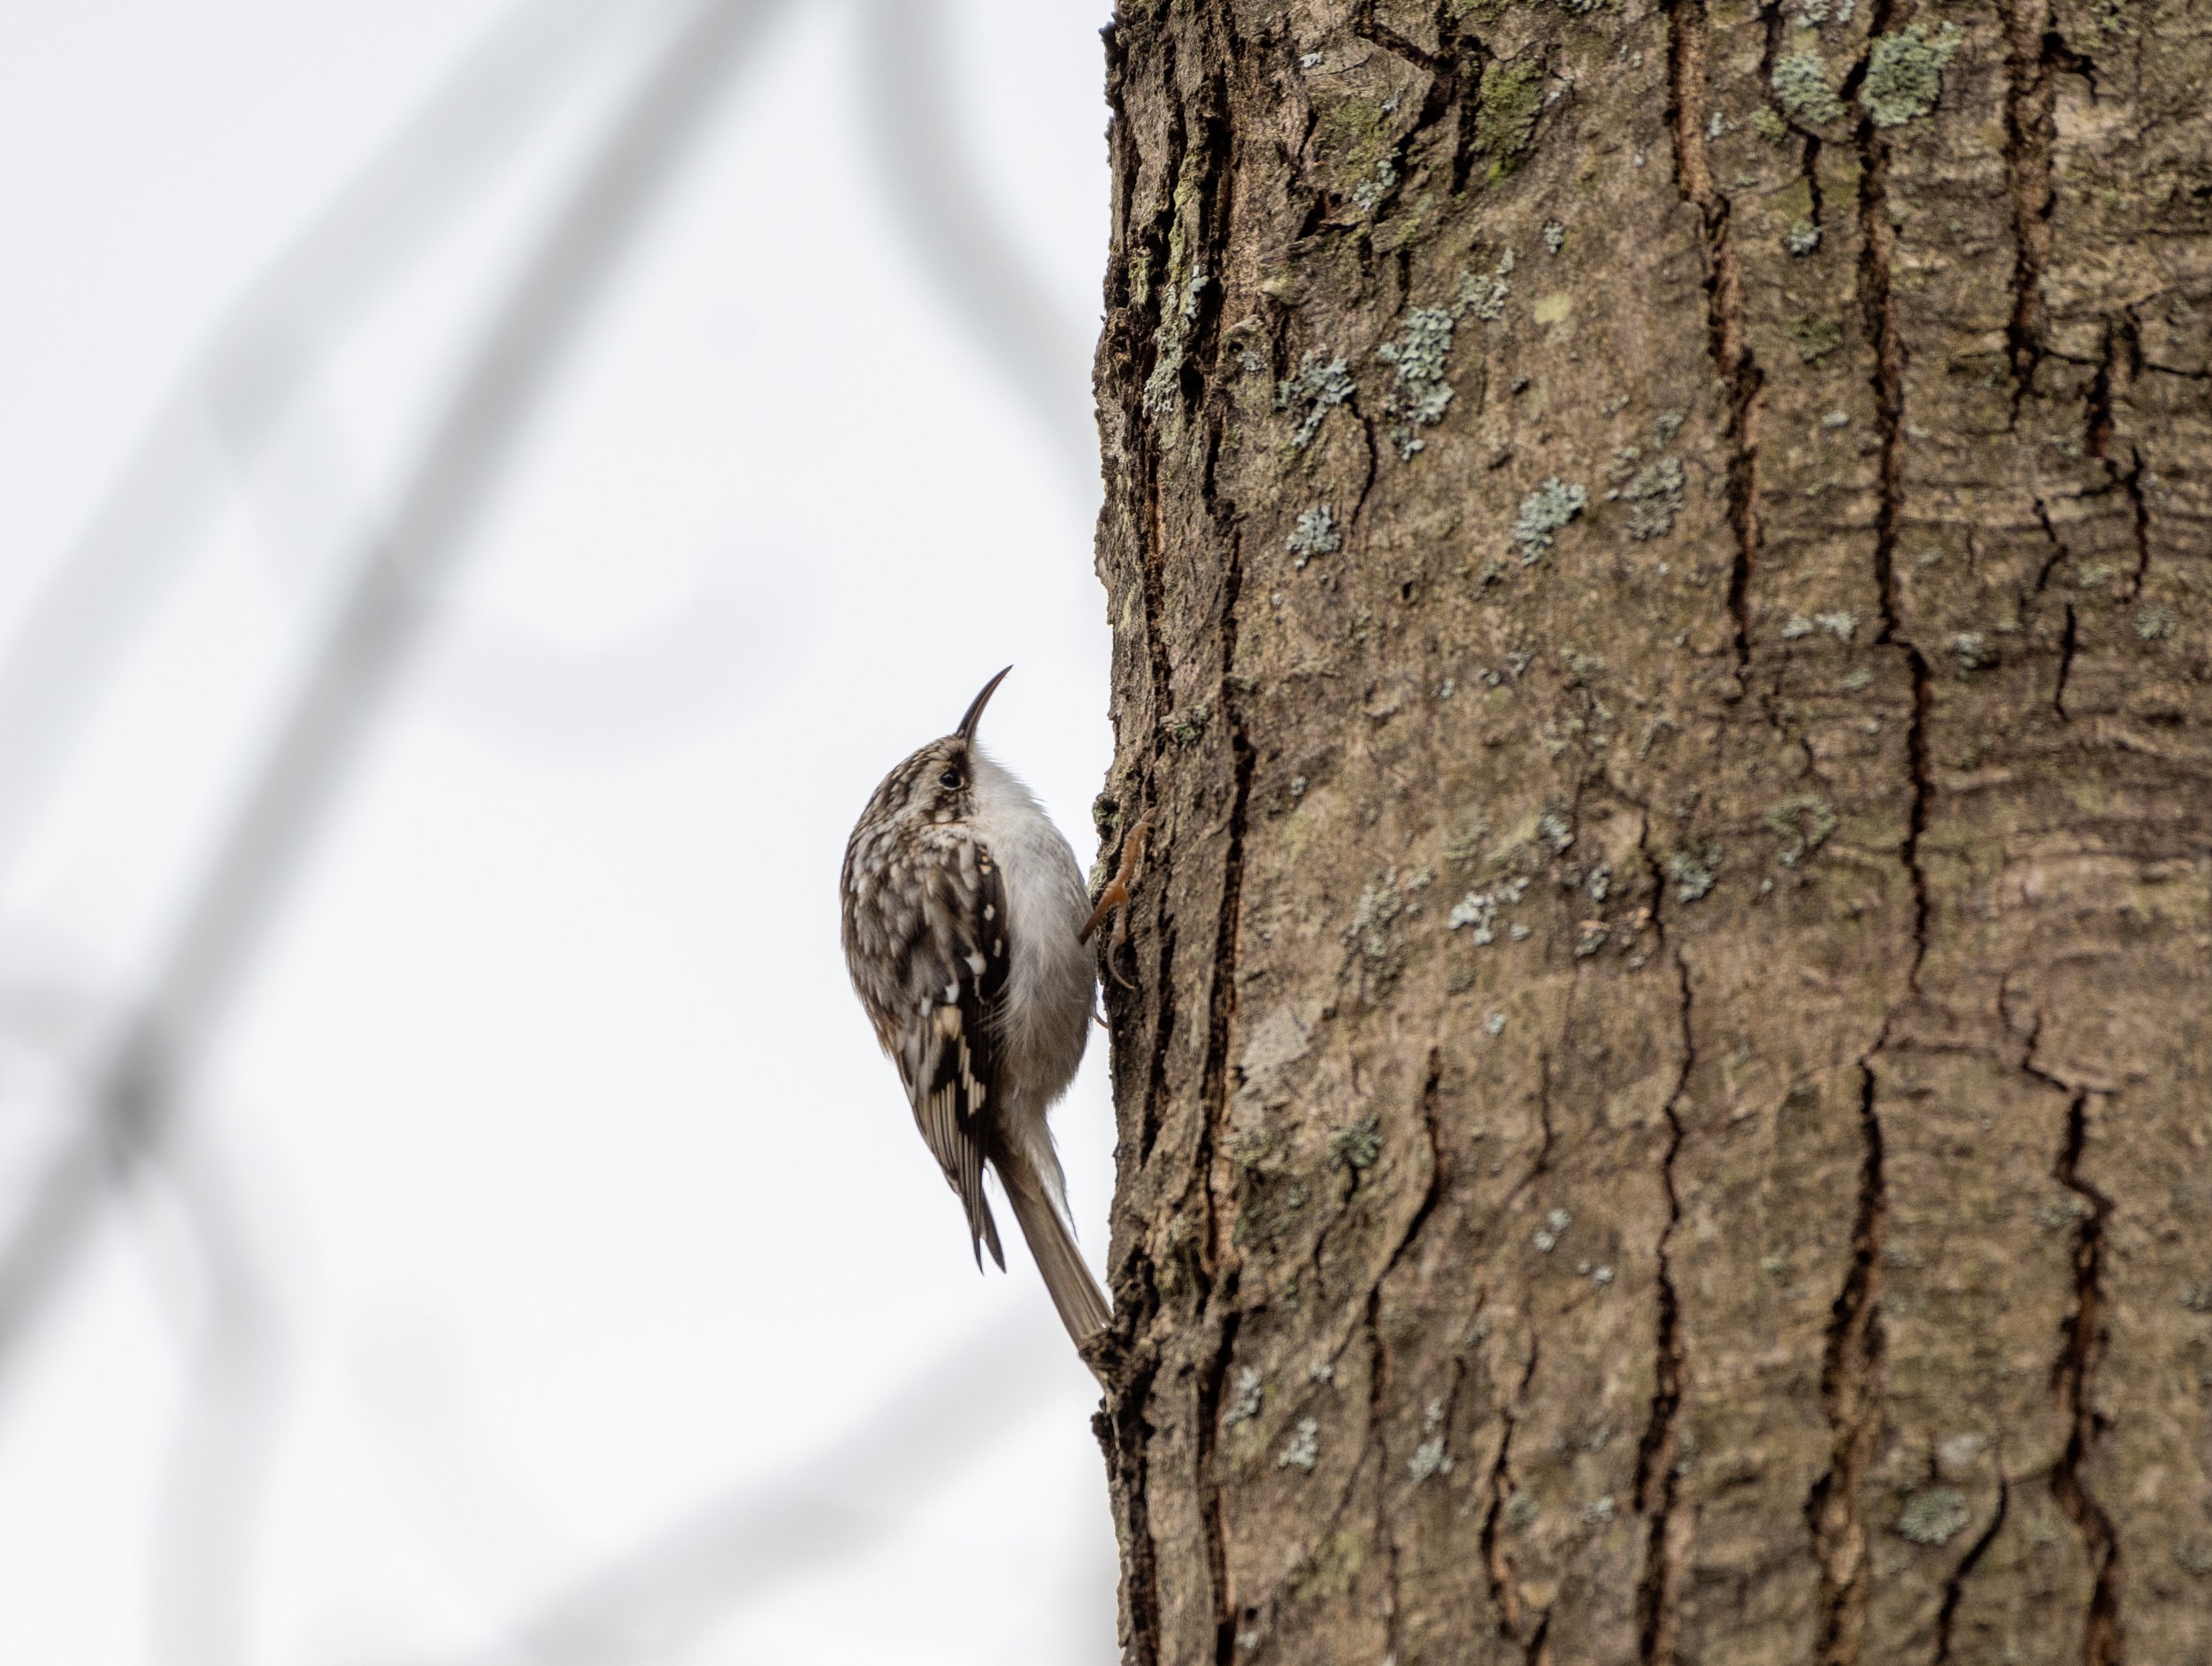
[1100,0,2212,1666]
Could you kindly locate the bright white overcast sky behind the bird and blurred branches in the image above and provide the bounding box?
[0,0,1115,1666]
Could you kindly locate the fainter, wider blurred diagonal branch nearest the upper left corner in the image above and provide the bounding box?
[0,0,672,867]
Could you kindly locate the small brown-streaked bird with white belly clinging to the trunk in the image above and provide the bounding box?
[841,666,1109,1345]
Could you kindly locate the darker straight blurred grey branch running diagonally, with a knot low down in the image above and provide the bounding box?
[0,0,801,1370]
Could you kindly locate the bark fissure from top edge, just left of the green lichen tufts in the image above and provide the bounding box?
[1668,0,1765,675]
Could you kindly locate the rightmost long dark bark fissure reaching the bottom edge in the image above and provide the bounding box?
[2031,1093,2126,1666]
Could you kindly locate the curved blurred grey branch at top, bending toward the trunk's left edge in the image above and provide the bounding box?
[858,0,1097,480]
